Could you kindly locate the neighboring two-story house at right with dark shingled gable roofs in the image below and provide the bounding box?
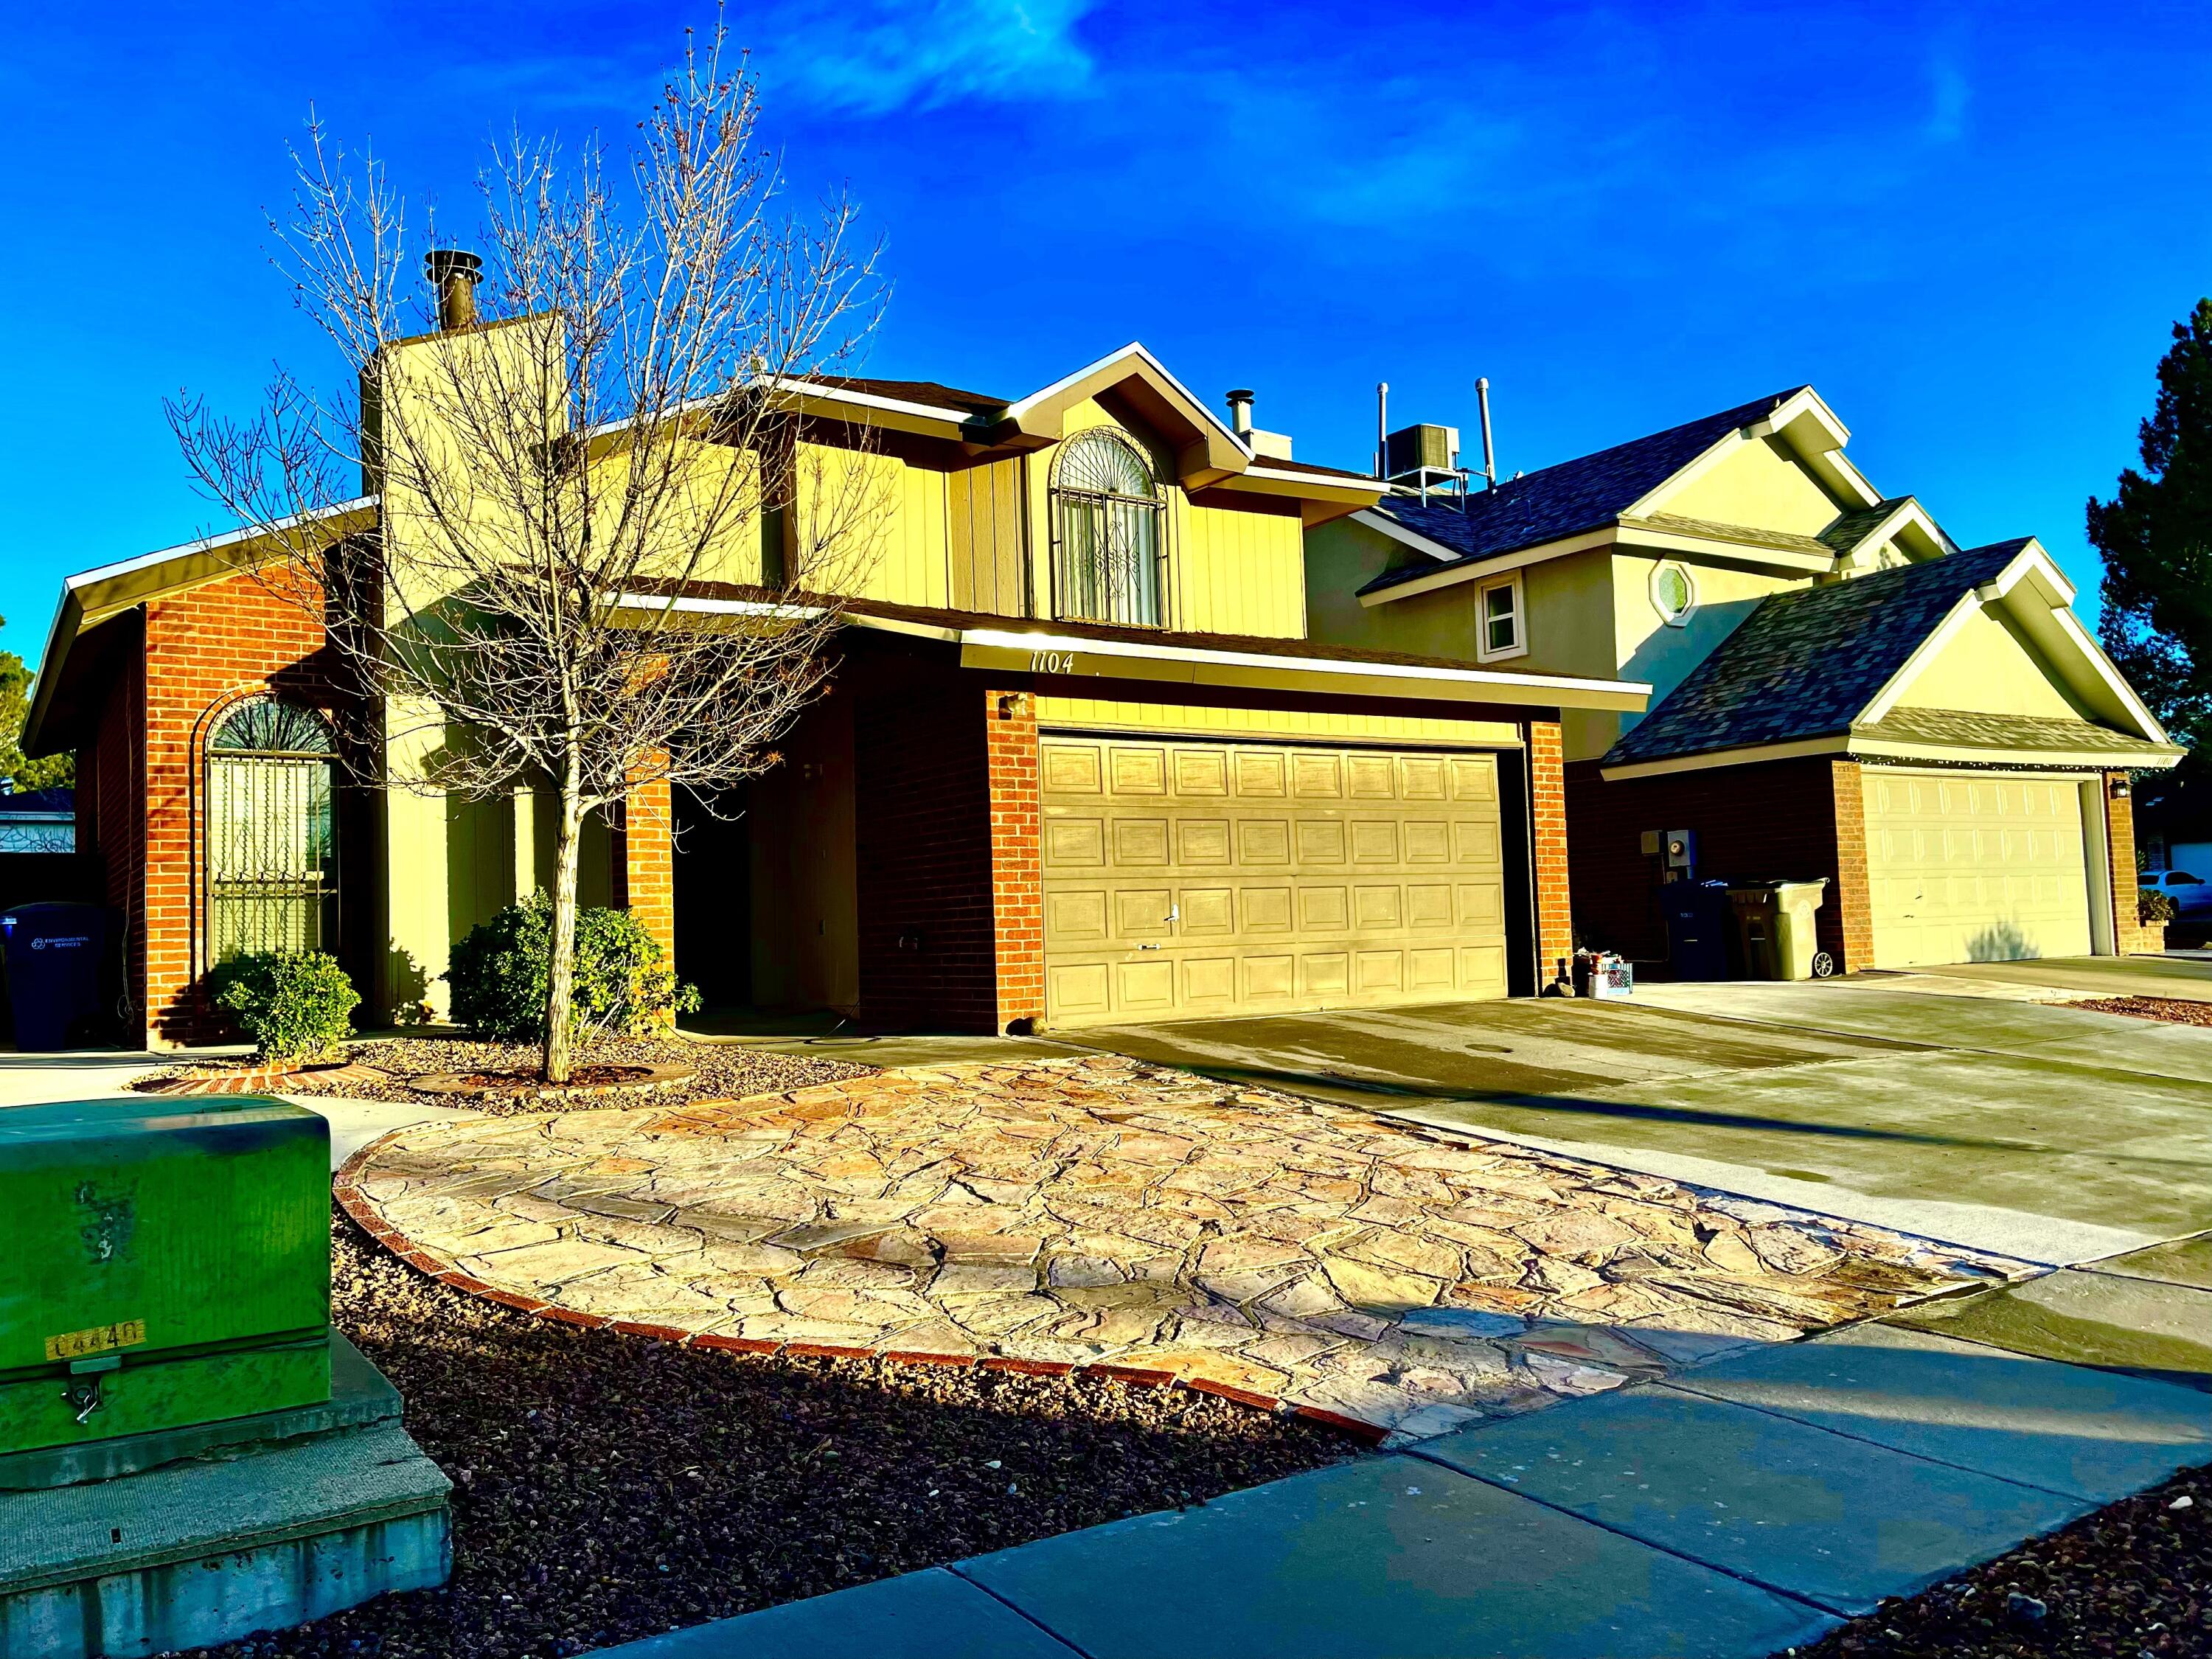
[1307,387,2181,971]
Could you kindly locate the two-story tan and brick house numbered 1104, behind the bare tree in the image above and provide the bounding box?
[24,319,1646,1042]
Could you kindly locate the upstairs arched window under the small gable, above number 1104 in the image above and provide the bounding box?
[1053,427,1166,628]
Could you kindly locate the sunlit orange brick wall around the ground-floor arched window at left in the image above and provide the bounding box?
[138,575,334,1044]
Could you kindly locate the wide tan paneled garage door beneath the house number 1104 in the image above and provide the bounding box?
[1042,732,1506,1026]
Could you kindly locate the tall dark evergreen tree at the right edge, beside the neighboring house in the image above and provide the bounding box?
[2088,299,2212,818]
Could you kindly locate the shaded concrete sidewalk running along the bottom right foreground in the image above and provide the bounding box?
[588,1239,2212,1659]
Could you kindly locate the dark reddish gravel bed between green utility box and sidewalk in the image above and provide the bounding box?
[186,1212,1363,1659]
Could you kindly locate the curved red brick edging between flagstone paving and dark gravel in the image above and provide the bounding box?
[330,1124,1389,1447]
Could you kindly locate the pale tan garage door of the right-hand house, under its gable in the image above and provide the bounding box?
[1863,768,2090,967]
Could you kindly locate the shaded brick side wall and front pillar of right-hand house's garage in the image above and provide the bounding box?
[1566,757,1874,973]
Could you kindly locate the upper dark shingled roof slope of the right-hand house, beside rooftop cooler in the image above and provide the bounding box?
[1360,387,1807,593]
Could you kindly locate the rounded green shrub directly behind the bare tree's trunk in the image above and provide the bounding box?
[445,894,699,1042]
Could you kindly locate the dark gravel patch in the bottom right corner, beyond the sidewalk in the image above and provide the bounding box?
[1790,1467,2212,1659]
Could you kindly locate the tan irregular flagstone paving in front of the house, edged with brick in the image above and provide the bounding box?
[338,1057,2026,1440]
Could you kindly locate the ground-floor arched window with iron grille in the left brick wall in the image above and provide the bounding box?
[206,697,338,964]
